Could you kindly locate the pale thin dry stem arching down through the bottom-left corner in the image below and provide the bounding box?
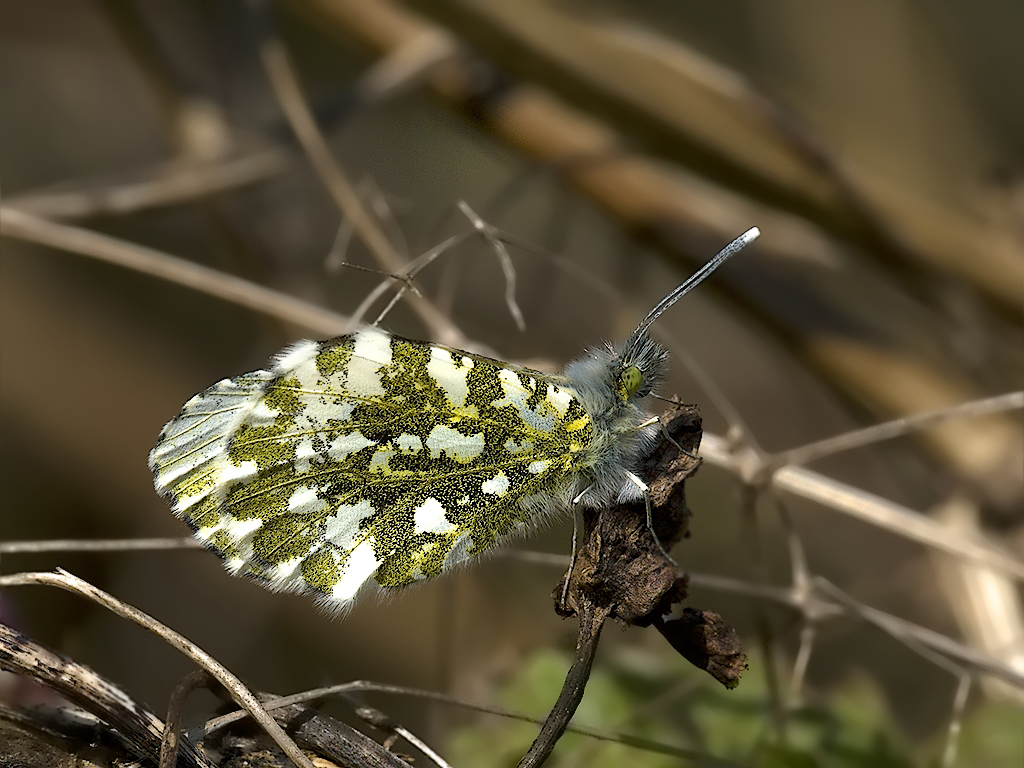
[0,570,313,768]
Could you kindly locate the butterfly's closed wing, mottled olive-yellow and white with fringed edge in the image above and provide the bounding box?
[150,328,593,607]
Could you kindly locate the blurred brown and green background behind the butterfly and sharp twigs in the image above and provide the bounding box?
[0,0,1024,766]
